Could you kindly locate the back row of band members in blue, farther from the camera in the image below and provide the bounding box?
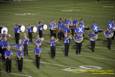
[9,18,115,44]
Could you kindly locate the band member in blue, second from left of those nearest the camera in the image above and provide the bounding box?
[16,46,24,72]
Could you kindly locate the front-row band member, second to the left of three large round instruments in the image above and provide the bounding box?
[50,36,57,58]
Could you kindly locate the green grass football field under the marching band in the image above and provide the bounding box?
[0,0,115,77]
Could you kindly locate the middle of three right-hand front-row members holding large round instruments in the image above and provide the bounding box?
[89,31,98,52]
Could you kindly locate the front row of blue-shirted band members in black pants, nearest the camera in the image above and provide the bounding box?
[0,18,114,72]
